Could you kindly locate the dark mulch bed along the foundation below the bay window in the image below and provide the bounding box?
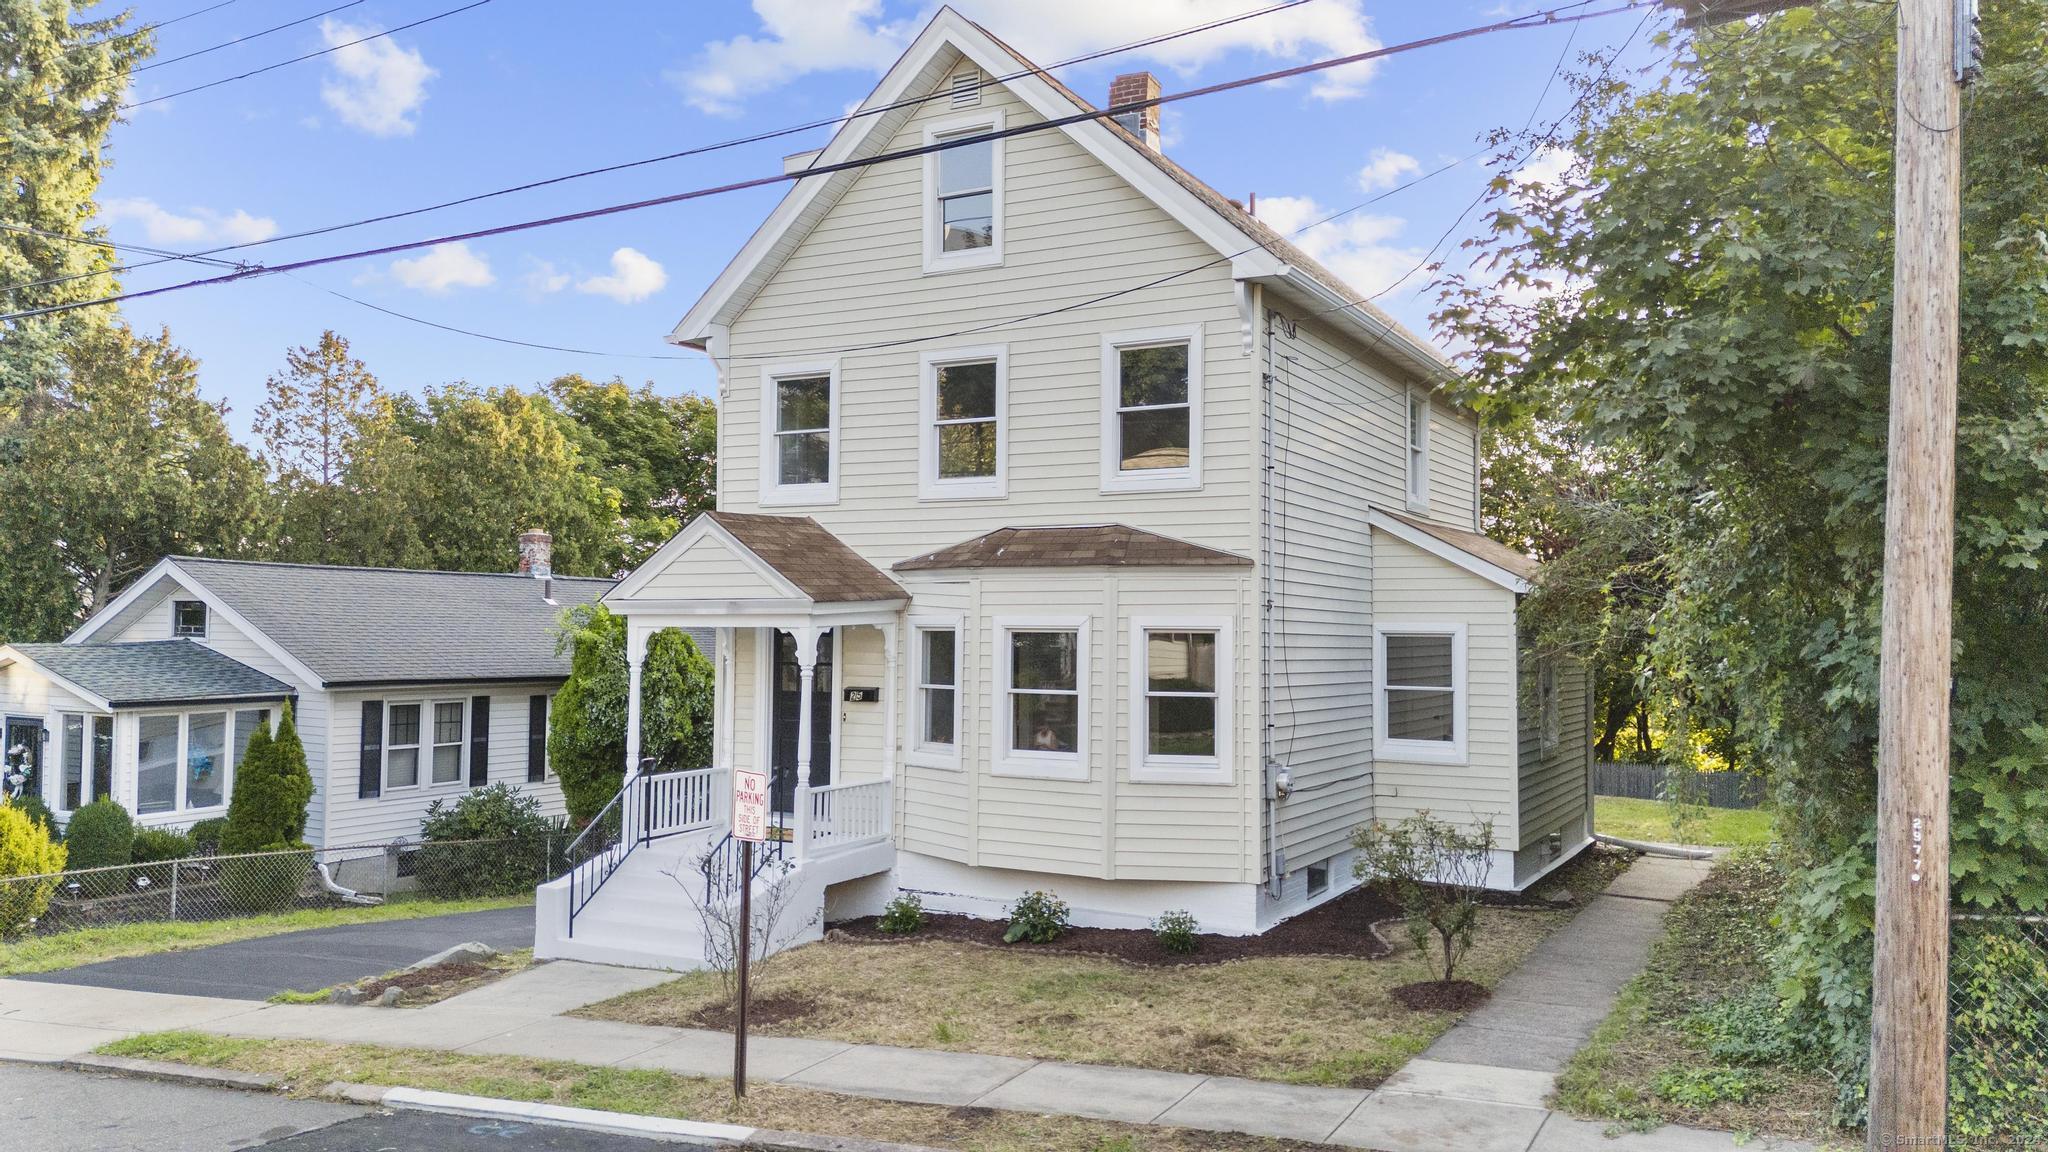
[831,888,1401,968]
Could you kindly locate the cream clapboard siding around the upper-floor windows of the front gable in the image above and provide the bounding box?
[719,53,1257,568]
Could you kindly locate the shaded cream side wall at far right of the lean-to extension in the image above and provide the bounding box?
[1516,652,1593,883]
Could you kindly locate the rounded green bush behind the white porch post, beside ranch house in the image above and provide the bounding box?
[547,605,713,824]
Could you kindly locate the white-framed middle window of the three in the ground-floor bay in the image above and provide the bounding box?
[993,617,1087,779]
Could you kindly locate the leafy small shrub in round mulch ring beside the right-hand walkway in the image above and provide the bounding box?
[1352,812,1493,984]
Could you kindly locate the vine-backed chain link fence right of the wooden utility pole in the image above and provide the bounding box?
[1948,914,2048,1148]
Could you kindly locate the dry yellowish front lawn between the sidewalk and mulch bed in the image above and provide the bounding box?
[578,908,1571,1086]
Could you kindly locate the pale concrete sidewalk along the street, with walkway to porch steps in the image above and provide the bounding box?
[0,947,1804,1152]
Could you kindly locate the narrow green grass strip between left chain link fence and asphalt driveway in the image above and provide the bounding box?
[0,896,532,976]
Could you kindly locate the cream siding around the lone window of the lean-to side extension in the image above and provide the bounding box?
[1372,533,1520,849]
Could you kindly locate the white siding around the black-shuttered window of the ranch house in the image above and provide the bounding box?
[326,683,567,847]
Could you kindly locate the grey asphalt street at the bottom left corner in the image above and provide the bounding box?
[0,1064,711,1152]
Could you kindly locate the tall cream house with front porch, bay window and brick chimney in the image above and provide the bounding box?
[539,8,1591,968]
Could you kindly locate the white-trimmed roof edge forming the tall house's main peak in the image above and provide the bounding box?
[670,8,1454,379]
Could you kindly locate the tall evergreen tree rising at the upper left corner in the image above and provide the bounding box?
[0,0,156,403]
